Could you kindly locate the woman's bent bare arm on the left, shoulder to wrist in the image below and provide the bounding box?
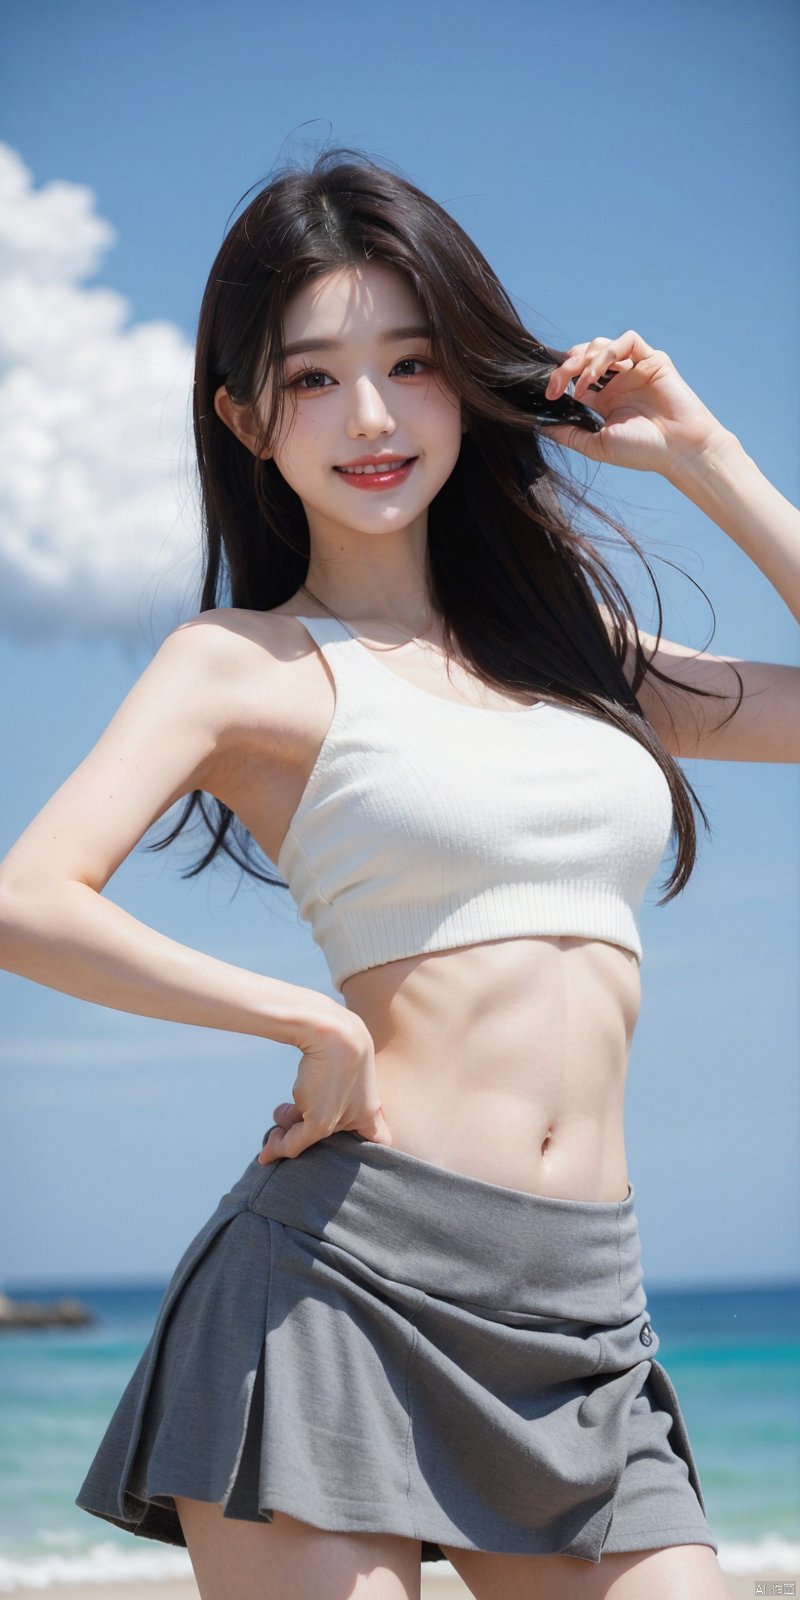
[0,613,334,1050]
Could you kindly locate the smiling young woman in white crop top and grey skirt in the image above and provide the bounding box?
[0,150,800,1600]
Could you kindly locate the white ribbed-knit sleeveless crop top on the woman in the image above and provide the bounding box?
[275,616,672,992]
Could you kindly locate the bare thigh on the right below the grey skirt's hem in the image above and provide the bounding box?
[442,1544,733,1600]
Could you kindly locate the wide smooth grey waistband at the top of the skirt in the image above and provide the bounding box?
[245,1133,646,1331]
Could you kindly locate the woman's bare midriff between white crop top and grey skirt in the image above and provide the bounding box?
[342,938,638,1200]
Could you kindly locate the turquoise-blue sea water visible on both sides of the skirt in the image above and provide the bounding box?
[0,1283,800,1592]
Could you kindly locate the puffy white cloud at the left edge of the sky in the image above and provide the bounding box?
[0,142,202,645]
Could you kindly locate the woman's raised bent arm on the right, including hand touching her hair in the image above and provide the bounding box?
[539,330,800,762]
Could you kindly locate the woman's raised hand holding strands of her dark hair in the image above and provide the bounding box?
[536,330,730,475]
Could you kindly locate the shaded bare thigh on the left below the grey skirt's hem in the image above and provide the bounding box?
[174,1494,422,1600]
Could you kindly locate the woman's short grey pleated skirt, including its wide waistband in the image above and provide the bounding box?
[77,1133,717,1562]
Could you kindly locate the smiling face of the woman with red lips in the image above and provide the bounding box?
[218,261,462,534]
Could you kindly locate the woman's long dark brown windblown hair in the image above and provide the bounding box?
[147,147,742,906]
